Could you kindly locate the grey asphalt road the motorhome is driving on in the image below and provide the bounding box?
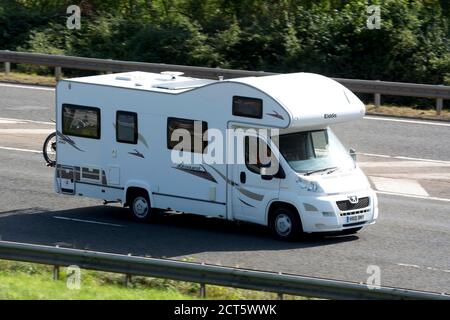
[0,85,450,292]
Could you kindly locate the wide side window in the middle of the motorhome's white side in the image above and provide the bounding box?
[167,118,208,153]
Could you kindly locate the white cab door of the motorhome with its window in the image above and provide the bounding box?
[232,133,280,223]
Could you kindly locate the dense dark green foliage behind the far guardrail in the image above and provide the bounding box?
[0,0,450,84]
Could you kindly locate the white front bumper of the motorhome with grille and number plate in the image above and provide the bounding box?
[299,190,378,233]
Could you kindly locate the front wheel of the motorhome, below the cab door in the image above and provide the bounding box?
[269,207,303,241]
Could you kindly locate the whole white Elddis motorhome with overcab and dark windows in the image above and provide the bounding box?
[55,72,378,239]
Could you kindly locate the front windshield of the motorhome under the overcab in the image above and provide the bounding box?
[279,129,355,175]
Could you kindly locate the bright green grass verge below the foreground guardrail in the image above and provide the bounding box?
[0,260,303,300]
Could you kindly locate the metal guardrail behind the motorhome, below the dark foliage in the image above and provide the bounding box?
[0,50,450,114]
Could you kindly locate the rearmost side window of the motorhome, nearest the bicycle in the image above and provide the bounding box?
[62,104,100,139]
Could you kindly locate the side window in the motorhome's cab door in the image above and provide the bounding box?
[244,136,272,174]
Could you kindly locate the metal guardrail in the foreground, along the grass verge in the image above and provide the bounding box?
[0,241,450,300]
